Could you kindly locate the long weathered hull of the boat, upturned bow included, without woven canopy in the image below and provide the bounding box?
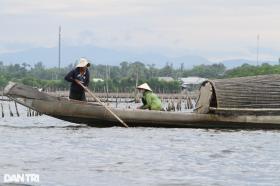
[4,83,280,129]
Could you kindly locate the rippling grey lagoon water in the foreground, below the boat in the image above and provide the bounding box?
[0,104,280,186]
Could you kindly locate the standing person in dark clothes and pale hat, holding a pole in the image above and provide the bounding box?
[64,58,90,101]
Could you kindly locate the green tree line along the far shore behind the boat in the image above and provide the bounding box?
[0,61,280,93]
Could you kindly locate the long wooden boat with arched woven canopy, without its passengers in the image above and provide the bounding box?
[4,75,280,129]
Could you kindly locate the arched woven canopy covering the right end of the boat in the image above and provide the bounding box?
[196,75,280,113]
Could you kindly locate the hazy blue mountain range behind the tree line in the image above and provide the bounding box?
[0,46,278,68]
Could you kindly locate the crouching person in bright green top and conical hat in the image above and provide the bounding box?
[137,83,162,110]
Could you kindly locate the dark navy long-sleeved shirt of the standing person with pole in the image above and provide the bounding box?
[64,68,90,93]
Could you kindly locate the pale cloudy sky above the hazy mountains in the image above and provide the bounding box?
[0,0,280,61]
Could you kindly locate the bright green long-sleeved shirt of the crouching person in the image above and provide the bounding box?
[141,91,161,110]
